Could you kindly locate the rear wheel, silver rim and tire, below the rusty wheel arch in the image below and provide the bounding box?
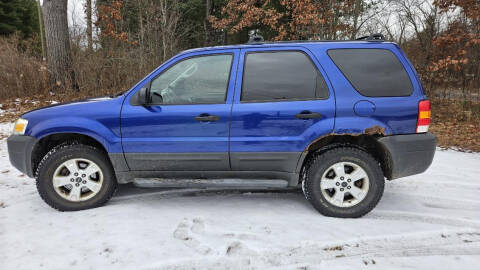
[303,147,384,218]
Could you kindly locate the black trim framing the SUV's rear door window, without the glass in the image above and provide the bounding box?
[239,49,330,103]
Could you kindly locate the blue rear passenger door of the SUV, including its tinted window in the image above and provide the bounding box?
[230,47,335,172]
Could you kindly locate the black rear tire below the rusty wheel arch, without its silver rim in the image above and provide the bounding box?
[302,147,385,218]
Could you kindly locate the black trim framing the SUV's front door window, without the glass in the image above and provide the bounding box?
[142,52,235,106]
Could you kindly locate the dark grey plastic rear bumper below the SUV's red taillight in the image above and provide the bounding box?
[378,133,437,179]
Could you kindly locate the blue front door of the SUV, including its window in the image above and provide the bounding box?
[121,50,239,171]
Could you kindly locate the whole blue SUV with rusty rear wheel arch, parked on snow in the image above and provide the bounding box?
[8,36,436,217]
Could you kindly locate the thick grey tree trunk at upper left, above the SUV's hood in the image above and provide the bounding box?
[42,0,78,90]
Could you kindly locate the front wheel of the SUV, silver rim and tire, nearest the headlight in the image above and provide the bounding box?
[36,144,116,211]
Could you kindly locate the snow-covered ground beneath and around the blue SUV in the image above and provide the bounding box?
[0,124,480,269]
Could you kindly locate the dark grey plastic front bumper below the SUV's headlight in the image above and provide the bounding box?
[7,135,37,178]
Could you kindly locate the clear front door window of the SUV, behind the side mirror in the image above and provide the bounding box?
[149,54,233,105]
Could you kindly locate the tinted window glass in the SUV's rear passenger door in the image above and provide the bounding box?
[241,51,328,102]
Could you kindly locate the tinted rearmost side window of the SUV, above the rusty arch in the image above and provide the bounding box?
[328,49,413,97]
